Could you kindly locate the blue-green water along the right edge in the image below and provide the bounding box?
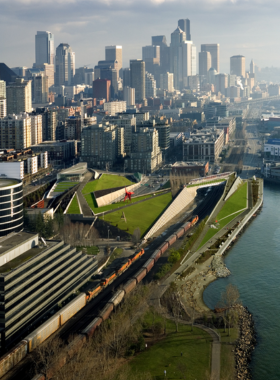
[204,184,280,380]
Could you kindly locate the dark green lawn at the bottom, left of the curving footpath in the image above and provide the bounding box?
[130,317,212,380]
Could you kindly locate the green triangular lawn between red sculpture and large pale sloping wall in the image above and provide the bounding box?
[104,192,172,236]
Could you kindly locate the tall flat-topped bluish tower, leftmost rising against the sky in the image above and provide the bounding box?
[35,32,54,65]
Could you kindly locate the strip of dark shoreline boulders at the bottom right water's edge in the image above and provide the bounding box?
[235,306,257,380]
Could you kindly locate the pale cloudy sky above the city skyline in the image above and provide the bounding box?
[0,0,280,72]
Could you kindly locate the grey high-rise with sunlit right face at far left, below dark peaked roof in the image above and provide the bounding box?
[6,78,32,115]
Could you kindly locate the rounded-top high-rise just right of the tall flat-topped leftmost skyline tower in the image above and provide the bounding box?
[55,44,75,86]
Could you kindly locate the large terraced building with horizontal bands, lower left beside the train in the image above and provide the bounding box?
[0,232,97,349]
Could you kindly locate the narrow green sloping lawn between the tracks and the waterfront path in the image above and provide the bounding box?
[199,182,248,248]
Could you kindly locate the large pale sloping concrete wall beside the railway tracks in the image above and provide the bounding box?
[144,187,196,240]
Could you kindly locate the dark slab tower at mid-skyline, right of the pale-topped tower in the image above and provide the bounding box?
[130,59,145,103]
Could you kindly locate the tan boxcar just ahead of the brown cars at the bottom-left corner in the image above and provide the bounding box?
[25,313,60,352]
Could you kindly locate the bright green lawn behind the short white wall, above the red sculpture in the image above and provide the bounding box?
[82,174,133,194]
